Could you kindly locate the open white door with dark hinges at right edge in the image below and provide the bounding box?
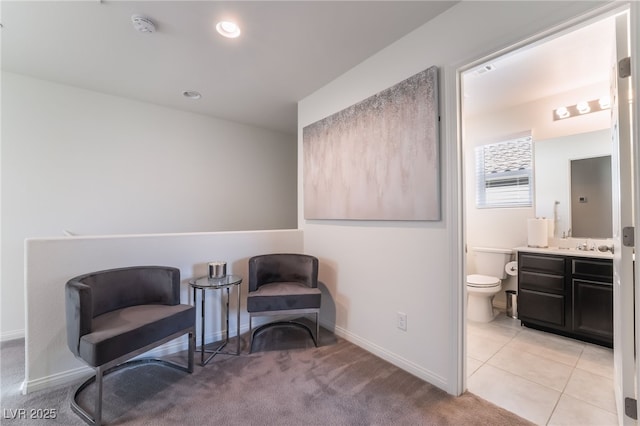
[611,8,638,425]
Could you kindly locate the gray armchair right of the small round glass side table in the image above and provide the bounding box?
[247,253,321,352]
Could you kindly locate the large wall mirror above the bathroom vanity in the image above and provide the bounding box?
[534,129,613,238]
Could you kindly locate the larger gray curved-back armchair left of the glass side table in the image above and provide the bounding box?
[65,266,195,425]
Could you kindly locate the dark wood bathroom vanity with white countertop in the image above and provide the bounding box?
[516,247,613,347]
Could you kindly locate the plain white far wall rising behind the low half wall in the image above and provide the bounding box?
[0,72,297,339]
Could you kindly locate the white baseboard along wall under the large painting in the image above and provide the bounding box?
[320,321,449,392]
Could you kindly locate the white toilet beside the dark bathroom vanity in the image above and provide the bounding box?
[467,247,513,322]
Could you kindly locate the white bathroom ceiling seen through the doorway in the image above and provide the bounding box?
[463,18,615,116]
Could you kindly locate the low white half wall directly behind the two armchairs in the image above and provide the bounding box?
[23,230,304,393]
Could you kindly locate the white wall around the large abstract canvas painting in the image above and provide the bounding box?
[298,2,608,394]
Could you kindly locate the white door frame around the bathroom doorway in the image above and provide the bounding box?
[452,2,640,420]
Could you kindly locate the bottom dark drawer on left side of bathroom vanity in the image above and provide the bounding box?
[518,290,565,327]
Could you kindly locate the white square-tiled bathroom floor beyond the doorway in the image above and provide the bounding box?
[467,313,618,426]
